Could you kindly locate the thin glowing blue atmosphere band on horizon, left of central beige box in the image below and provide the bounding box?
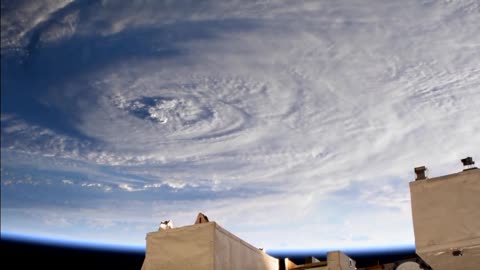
[1,232,145,253]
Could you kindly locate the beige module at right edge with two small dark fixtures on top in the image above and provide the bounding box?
[410,158,480,270]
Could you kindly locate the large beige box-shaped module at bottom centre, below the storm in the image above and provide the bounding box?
[142,222,279,270]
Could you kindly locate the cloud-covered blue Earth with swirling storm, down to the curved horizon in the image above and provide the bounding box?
[1,1,480,249]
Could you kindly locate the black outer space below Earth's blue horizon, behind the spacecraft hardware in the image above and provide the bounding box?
[1,239,415,270]
